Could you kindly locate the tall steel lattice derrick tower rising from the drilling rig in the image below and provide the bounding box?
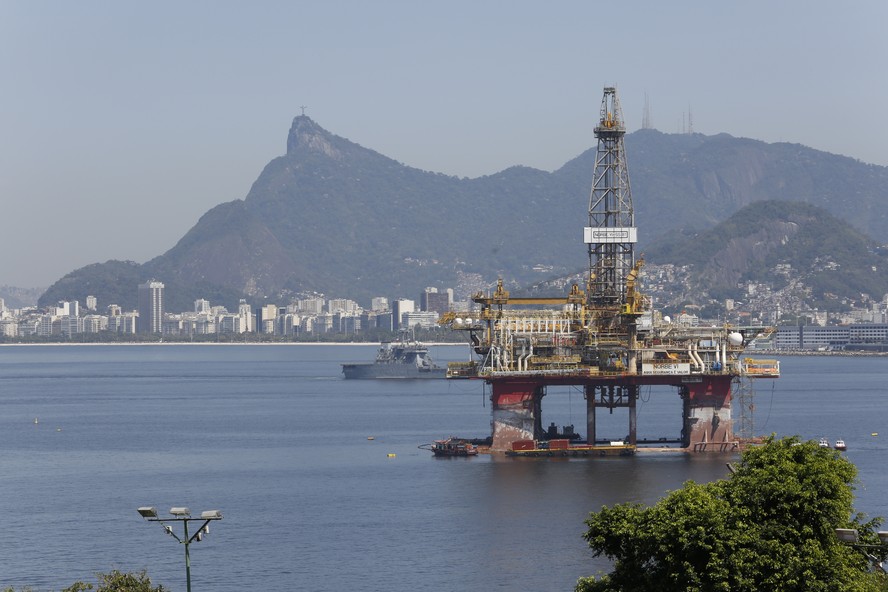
[583,87,637,306]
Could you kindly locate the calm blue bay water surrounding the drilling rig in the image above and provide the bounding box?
[0,345,888,592]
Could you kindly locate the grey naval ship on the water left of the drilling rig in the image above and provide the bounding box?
[342,332,447,378]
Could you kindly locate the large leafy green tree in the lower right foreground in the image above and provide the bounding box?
[576,436,885,592]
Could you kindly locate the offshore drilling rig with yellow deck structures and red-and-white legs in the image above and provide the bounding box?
[440,87,780,456]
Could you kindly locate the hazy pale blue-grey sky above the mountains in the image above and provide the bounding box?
[0,0,888,287]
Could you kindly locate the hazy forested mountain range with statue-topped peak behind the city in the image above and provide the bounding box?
[39,116,888,310]
